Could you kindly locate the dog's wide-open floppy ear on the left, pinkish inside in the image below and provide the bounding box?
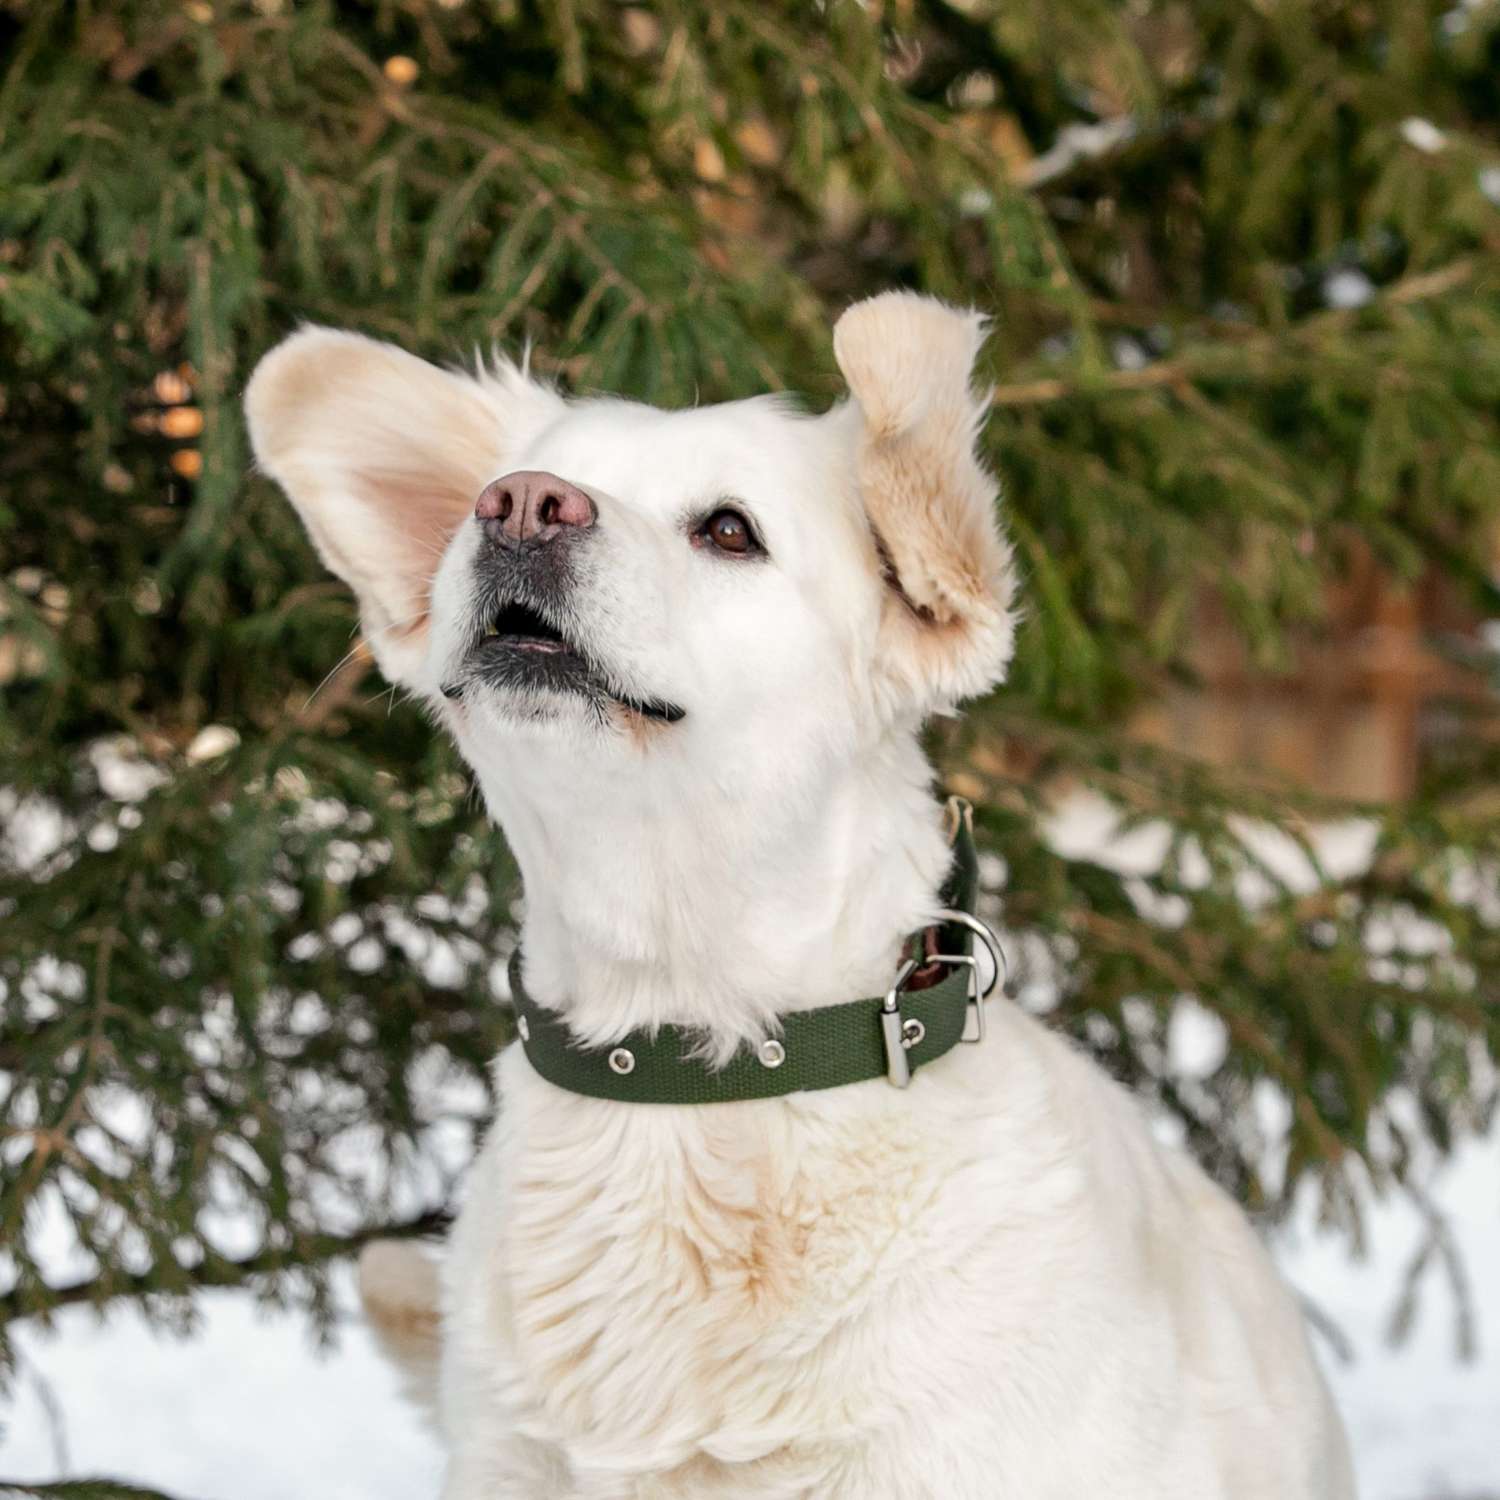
[245,327,563,683]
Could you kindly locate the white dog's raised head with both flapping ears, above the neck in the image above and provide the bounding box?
[246,293,1013,774]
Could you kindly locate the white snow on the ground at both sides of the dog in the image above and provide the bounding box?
[0,1130,1500,1500]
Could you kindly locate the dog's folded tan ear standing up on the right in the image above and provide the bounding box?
[834,293,1016,713]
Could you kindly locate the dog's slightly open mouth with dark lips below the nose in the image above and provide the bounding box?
[443,600,686,725]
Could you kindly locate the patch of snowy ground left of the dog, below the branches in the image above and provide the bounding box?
[0,1271,443,1500]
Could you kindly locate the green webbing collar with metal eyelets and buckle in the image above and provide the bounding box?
[510,797,1002,1104]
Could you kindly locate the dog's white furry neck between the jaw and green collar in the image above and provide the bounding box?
[480,734,950,1056]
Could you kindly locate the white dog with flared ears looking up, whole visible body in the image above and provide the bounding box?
[248,293,1353,1500]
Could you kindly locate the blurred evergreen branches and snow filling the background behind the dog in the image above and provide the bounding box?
[0,0,1500,1500]
